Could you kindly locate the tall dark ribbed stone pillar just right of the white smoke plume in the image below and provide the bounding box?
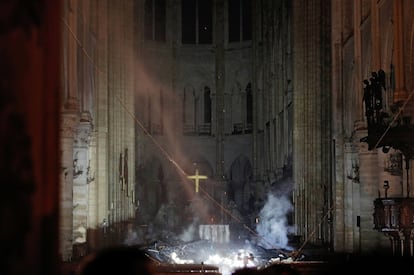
[293,1,331,242]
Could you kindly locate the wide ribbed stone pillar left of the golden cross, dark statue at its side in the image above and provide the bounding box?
[102,1,134,237]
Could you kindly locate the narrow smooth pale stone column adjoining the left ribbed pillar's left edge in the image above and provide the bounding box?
[87,0,109,250]
